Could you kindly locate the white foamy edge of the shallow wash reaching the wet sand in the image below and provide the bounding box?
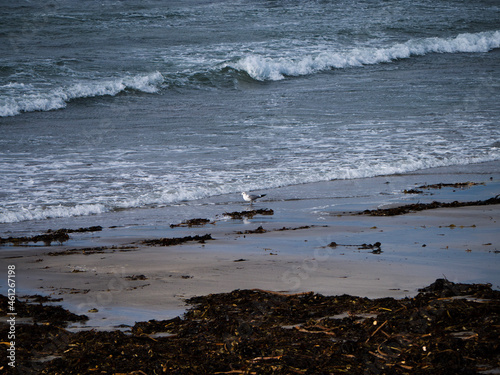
[0,152,500,223]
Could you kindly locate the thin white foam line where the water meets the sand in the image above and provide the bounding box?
[0,152,500,224]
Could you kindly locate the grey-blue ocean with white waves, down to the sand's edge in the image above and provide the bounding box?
[0,0,500,228]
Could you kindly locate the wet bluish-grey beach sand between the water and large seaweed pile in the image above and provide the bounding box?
[1,164,500,329]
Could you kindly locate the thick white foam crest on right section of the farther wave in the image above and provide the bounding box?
[229,30,500,81]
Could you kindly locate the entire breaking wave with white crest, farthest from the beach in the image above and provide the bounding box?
[0,30,500,117]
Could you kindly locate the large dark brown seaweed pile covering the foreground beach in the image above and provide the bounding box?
[0,279,500,375]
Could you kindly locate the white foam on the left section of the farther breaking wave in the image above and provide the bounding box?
[0,72,164,117]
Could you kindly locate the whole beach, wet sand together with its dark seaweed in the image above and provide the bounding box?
[0,163,500,374]
